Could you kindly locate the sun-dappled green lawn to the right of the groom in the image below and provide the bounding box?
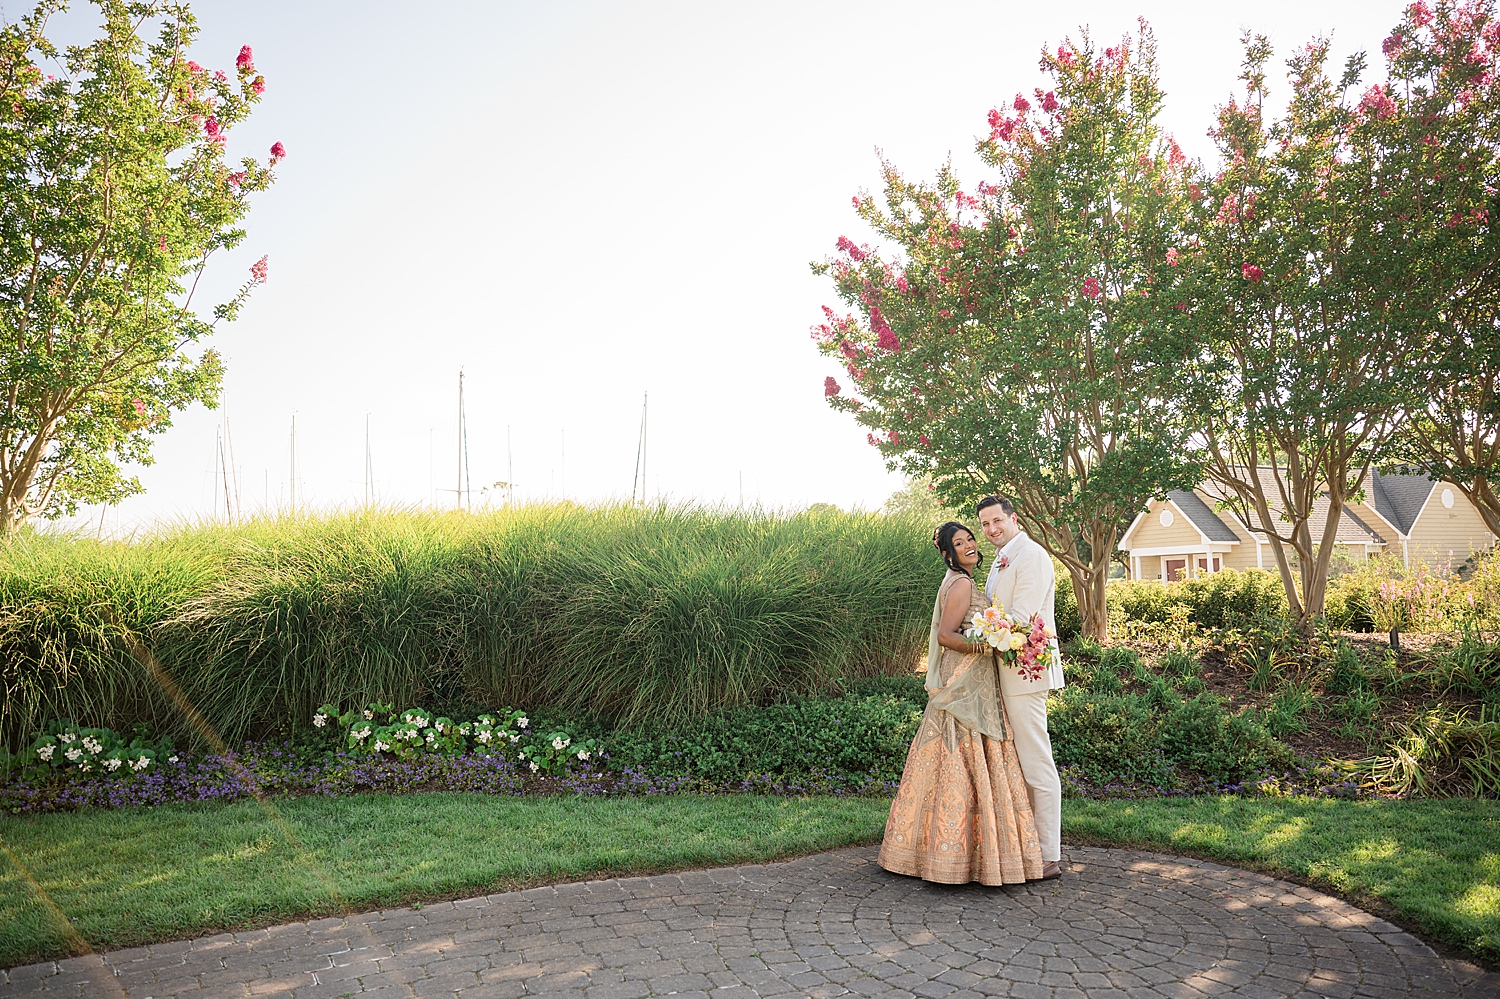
[1062,797,1500,966]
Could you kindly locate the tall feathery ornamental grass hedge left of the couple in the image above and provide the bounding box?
[0,504,944,747]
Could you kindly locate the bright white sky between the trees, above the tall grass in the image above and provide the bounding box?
[14,0,1401,533]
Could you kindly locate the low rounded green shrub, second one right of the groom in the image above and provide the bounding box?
[1161,693,1295,782]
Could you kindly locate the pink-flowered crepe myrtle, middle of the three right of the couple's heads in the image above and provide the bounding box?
[1179,3,1494,632]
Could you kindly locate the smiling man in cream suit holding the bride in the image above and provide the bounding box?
[975,497,1062,879]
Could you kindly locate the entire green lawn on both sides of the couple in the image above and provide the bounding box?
[0,794,1500,968]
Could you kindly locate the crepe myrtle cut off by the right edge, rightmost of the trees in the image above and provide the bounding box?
[1367,3,1500,537]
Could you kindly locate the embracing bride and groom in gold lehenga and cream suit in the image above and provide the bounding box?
[879,497,1062,885]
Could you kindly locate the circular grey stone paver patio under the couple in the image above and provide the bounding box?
[0,848,1500,999]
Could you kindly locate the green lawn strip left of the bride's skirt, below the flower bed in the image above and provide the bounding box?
[0,794,890,968]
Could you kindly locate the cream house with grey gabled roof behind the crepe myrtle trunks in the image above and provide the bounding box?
[1119,471,1496,581]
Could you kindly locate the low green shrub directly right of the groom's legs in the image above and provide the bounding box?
[1047,686,1167,782]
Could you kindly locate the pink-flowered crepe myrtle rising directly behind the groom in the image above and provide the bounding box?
[813,23,1197,638]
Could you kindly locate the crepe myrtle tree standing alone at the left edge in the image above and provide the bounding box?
[0,0,285,537]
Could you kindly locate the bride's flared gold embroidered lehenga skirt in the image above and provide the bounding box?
[879,651,1043,885]
